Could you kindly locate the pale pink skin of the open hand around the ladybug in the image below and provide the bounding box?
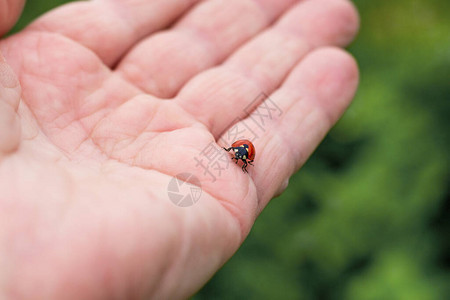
[0,0,358,299]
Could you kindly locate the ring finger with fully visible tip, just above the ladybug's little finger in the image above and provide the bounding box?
[176,0,358,137]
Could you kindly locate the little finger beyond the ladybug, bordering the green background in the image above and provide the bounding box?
[232,48,358,210]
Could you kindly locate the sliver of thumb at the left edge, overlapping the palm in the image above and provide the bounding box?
[0,53,21,159]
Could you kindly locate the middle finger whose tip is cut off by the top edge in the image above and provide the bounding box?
[117,0,296,98]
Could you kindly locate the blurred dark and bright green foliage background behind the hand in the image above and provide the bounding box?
[10,0,450,300]
